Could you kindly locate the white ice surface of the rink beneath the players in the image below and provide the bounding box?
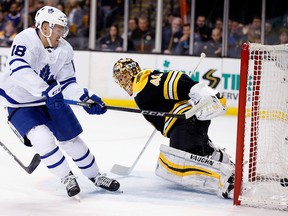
[0,107,287,216]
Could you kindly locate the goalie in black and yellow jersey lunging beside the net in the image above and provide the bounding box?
[113,58,234,198]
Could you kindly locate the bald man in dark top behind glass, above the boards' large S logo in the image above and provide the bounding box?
[203,28,222,57]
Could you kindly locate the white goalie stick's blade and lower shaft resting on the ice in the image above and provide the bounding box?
[110,129,157,176]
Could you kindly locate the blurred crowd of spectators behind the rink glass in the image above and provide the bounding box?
[0,0,288,58]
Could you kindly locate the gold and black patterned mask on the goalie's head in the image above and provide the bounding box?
[113,58,141,96]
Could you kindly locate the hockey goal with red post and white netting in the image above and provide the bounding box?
[234,43,288,211]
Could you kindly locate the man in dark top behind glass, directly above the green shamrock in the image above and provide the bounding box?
[162,17,183,54]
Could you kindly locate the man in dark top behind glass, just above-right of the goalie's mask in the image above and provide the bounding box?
[131,16,155,52]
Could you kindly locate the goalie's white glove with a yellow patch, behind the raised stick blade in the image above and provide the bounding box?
[189,83,227,121]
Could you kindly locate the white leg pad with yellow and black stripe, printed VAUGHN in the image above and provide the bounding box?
[155,145,234,197]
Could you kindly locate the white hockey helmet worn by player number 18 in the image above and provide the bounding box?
[35,6,69,38]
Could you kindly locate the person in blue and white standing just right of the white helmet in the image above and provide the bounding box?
[68,0,83,36]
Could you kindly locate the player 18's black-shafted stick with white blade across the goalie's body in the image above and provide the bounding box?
[64,97,213,119]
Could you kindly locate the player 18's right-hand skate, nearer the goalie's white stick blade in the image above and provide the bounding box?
[90,173,120,191]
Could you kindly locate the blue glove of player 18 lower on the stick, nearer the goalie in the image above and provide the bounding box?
[80,88,107,115]
